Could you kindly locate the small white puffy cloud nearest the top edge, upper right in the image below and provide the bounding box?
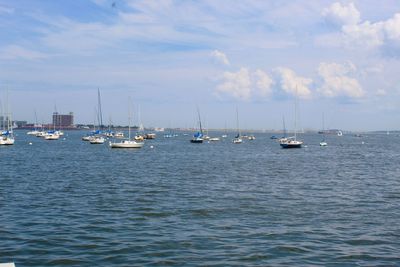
[322,2,360,26]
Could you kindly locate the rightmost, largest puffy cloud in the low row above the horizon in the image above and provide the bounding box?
[318,62,364,98]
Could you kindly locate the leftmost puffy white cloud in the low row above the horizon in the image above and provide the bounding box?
[217,68,251,100]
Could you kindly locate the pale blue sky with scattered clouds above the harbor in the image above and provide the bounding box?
[0,0,400,131]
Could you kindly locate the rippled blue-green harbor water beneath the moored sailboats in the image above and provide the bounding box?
[0,132,400,267]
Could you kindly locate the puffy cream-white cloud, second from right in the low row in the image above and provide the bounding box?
[275,67,313,98]
